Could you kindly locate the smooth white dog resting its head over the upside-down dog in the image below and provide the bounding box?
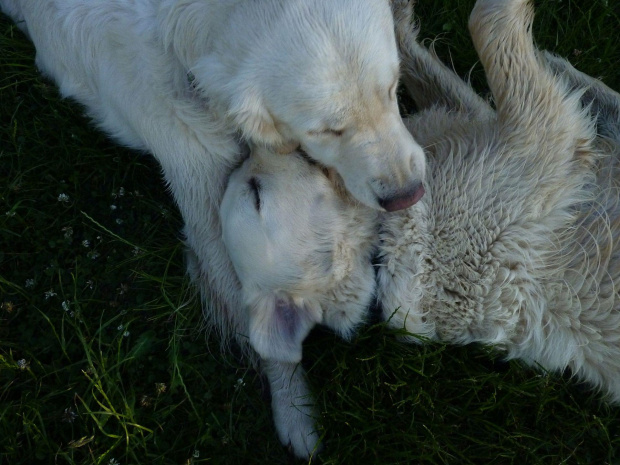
[0,0,425,456]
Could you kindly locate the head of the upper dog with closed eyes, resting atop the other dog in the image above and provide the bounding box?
[193,0,425,211]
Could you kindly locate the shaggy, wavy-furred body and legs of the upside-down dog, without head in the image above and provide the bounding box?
[378,0,620,401]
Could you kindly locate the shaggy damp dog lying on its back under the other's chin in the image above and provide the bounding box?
[223,0,620,432]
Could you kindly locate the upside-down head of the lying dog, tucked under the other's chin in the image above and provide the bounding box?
[220,149,376,362]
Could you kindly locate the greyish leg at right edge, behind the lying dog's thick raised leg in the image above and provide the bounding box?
[541,52,620,143]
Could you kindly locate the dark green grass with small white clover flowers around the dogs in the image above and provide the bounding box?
[0,0,620,465]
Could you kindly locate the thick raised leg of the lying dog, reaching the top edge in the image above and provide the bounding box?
[469,0,594,170]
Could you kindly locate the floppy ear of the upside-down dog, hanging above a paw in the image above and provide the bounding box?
[250,295,321,363]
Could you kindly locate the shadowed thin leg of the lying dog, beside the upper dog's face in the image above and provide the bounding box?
[392,0,493,118]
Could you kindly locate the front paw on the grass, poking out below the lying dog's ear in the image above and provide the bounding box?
[262,360,320,458]
